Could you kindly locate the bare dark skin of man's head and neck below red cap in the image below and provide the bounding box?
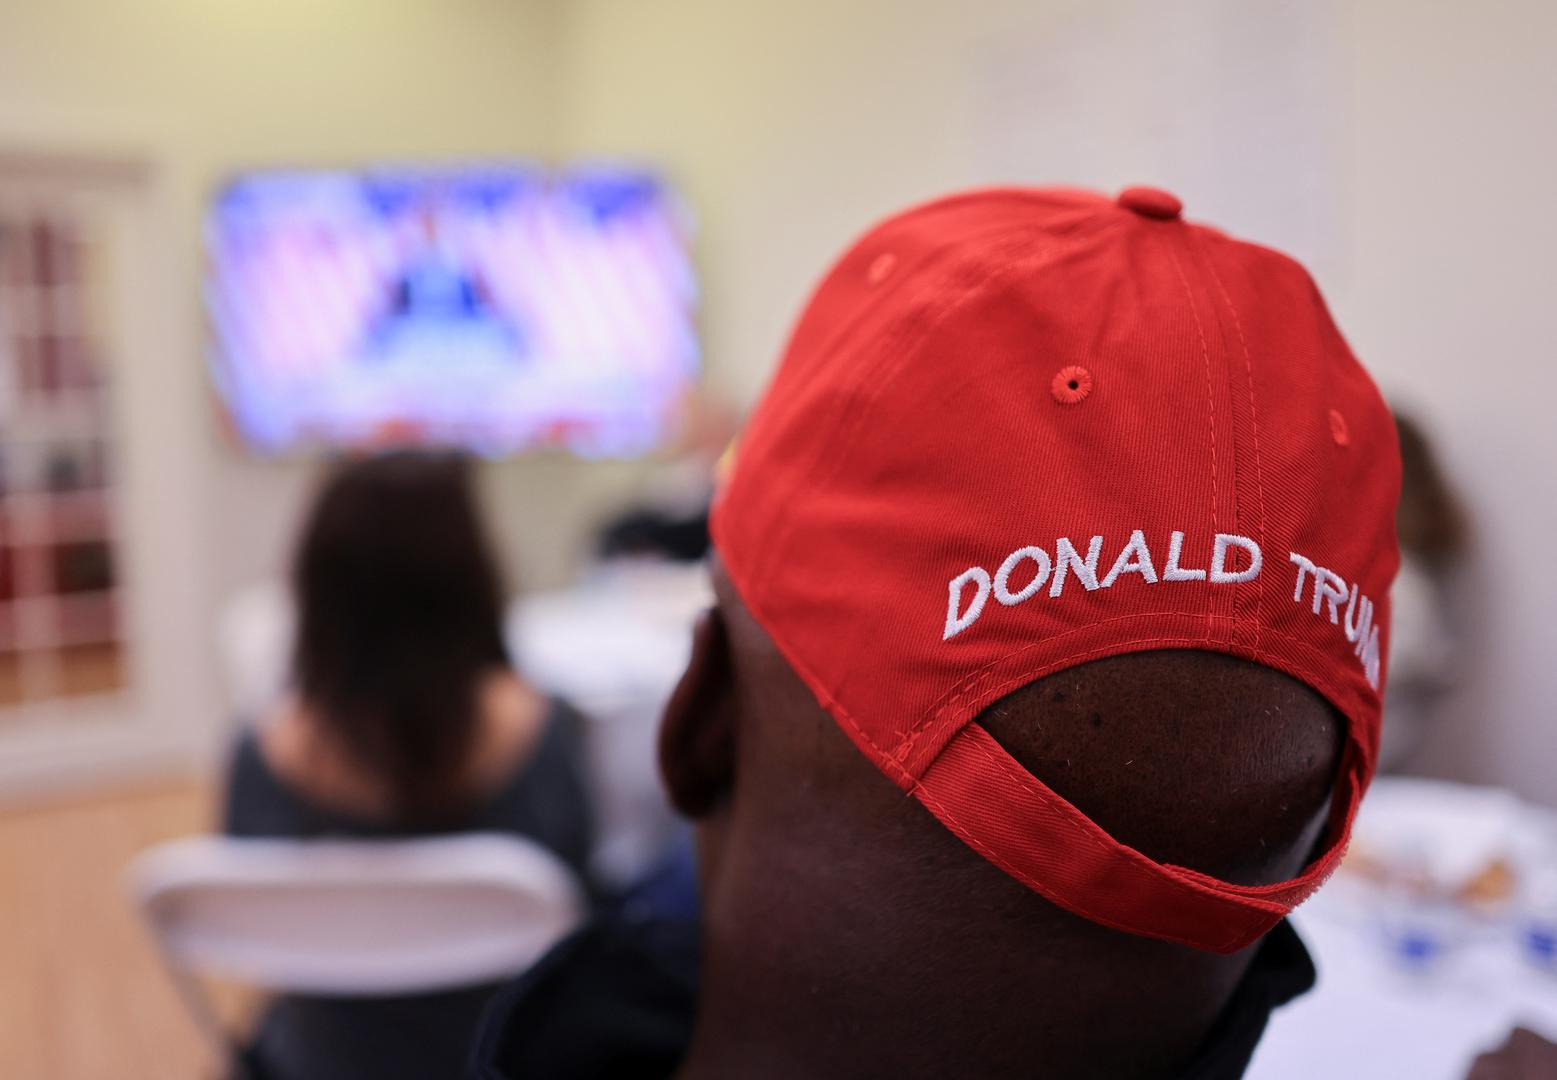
[660,560,1344,1080]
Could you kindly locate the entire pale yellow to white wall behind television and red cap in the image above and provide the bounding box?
[0,0,1557,801]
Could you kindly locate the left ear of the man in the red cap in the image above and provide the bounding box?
[660,608,735,819]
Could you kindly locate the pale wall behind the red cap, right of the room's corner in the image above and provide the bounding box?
[561,0,1557,803]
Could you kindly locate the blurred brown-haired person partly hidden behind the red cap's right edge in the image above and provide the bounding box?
[1380,411,1470,772]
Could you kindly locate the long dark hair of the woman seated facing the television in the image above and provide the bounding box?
[293,451,508,823]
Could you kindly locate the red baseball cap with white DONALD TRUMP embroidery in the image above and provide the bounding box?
[713,188,1400,952]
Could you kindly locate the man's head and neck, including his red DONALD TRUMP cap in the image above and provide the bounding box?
[662,190,1398,1069]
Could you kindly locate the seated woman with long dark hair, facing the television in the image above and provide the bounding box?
[224,453,592,1080]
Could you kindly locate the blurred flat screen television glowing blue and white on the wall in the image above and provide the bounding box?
[206,165,698,458]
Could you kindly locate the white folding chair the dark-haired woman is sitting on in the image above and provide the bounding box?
[129,834,584,1057]
